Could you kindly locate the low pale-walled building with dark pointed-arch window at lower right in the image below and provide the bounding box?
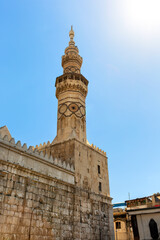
[126,193,160,240]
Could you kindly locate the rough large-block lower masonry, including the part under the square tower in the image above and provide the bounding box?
[0,161,113,240]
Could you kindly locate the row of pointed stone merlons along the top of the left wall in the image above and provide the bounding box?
[0,134,74,172]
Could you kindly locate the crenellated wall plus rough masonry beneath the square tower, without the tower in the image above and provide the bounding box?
[0,136,114,240]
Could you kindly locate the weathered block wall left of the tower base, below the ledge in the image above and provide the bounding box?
[0,163,74,240]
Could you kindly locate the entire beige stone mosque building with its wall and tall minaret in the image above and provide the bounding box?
[0,28,114,240]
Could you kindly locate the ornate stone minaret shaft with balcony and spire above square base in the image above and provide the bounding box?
[55,27,88,143]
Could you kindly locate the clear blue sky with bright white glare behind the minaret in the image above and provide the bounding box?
[0,0,160,202]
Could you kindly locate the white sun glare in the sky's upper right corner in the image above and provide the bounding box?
[125,0,160,35]
